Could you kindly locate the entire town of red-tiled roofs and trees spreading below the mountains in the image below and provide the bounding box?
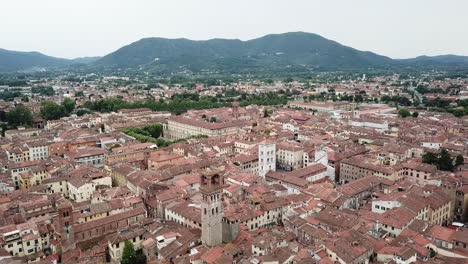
[0,68,468,264]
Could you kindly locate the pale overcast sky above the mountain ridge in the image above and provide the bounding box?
[0,0,468,58]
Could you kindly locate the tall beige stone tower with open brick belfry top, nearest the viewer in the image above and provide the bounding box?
[200,170,224,246]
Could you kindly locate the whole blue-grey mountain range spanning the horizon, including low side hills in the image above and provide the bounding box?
[0,32,468,73]
